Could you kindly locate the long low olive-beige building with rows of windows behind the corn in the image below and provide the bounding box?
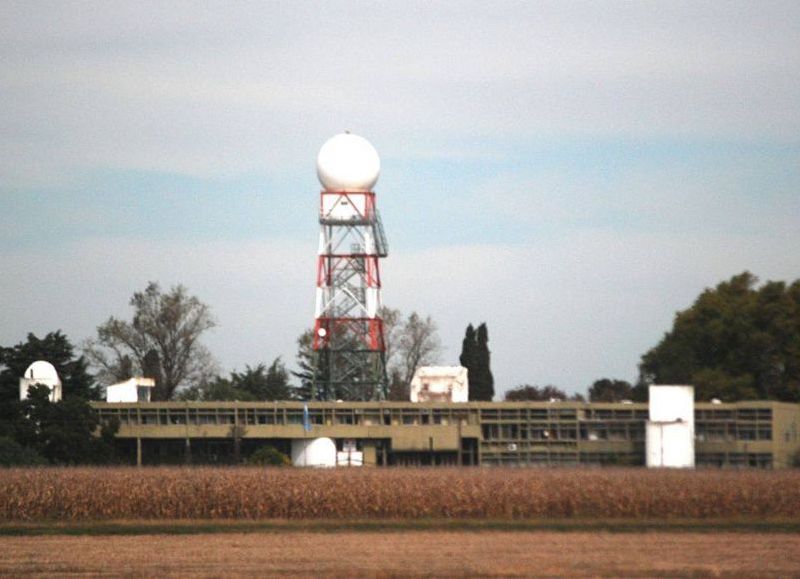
[93,401,800,469]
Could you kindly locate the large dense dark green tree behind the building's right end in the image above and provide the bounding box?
[634,271,800,402]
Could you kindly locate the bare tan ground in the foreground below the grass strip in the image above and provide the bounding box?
[0,531,800,577]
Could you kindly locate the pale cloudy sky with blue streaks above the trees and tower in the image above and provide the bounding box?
[0,0,800,396]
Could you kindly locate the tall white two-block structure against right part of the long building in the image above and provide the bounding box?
[645,386,694,468]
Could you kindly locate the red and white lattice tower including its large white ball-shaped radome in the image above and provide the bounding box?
[311,133,388,400]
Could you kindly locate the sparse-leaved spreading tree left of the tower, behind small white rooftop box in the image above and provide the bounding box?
[86,282,216,400]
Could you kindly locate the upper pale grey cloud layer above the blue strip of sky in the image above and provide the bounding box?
[0,2,800,183]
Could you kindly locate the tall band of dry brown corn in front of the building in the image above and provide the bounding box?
[0,467,800,522]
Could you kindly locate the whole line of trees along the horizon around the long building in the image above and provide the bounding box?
[0,272,800,463]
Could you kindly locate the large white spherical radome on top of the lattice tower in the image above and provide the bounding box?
[317,133,381,192]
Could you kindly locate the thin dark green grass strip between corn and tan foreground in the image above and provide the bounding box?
[0,519,800,536]
